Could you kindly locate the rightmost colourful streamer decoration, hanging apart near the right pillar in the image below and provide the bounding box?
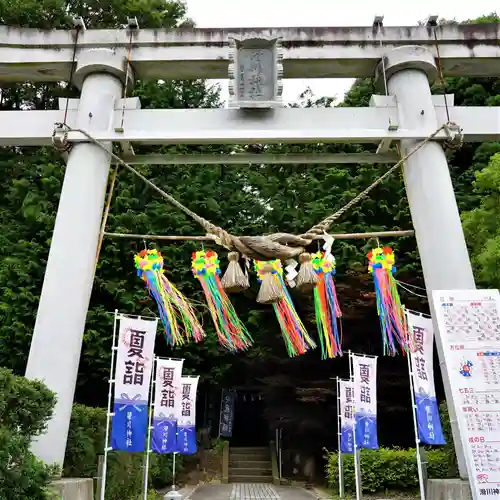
[368,247,412,356]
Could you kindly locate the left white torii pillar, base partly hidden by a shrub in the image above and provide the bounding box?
[26,49,132,466]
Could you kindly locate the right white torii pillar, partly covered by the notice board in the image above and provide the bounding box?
[376,45,476,479]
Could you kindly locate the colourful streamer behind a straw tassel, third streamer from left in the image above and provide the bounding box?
[254,260,316,357]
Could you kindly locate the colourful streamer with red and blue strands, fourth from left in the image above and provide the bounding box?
[312,252,342,359]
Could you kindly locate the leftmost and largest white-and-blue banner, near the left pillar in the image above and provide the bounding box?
[110,316,158,452]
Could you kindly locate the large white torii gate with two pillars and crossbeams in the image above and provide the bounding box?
[0,17,500,478]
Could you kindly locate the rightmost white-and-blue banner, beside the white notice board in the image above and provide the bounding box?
[406,311,446,445]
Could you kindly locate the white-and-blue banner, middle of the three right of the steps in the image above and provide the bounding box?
[351,354,378,450]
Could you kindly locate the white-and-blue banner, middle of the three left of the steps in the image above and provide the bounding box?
[151,358,184,454]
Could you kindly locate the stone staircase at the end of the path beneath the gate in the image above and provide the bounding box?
[229,446,273,483]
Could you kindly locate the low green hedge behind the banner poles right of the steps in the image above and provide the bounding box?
[326,448,449,493]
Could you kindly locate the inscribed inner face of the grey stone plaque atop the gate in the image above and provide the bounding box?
[238,48,275,101]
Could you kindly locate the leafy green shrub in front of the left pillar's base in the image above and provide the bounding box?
[0,368,55,500]
